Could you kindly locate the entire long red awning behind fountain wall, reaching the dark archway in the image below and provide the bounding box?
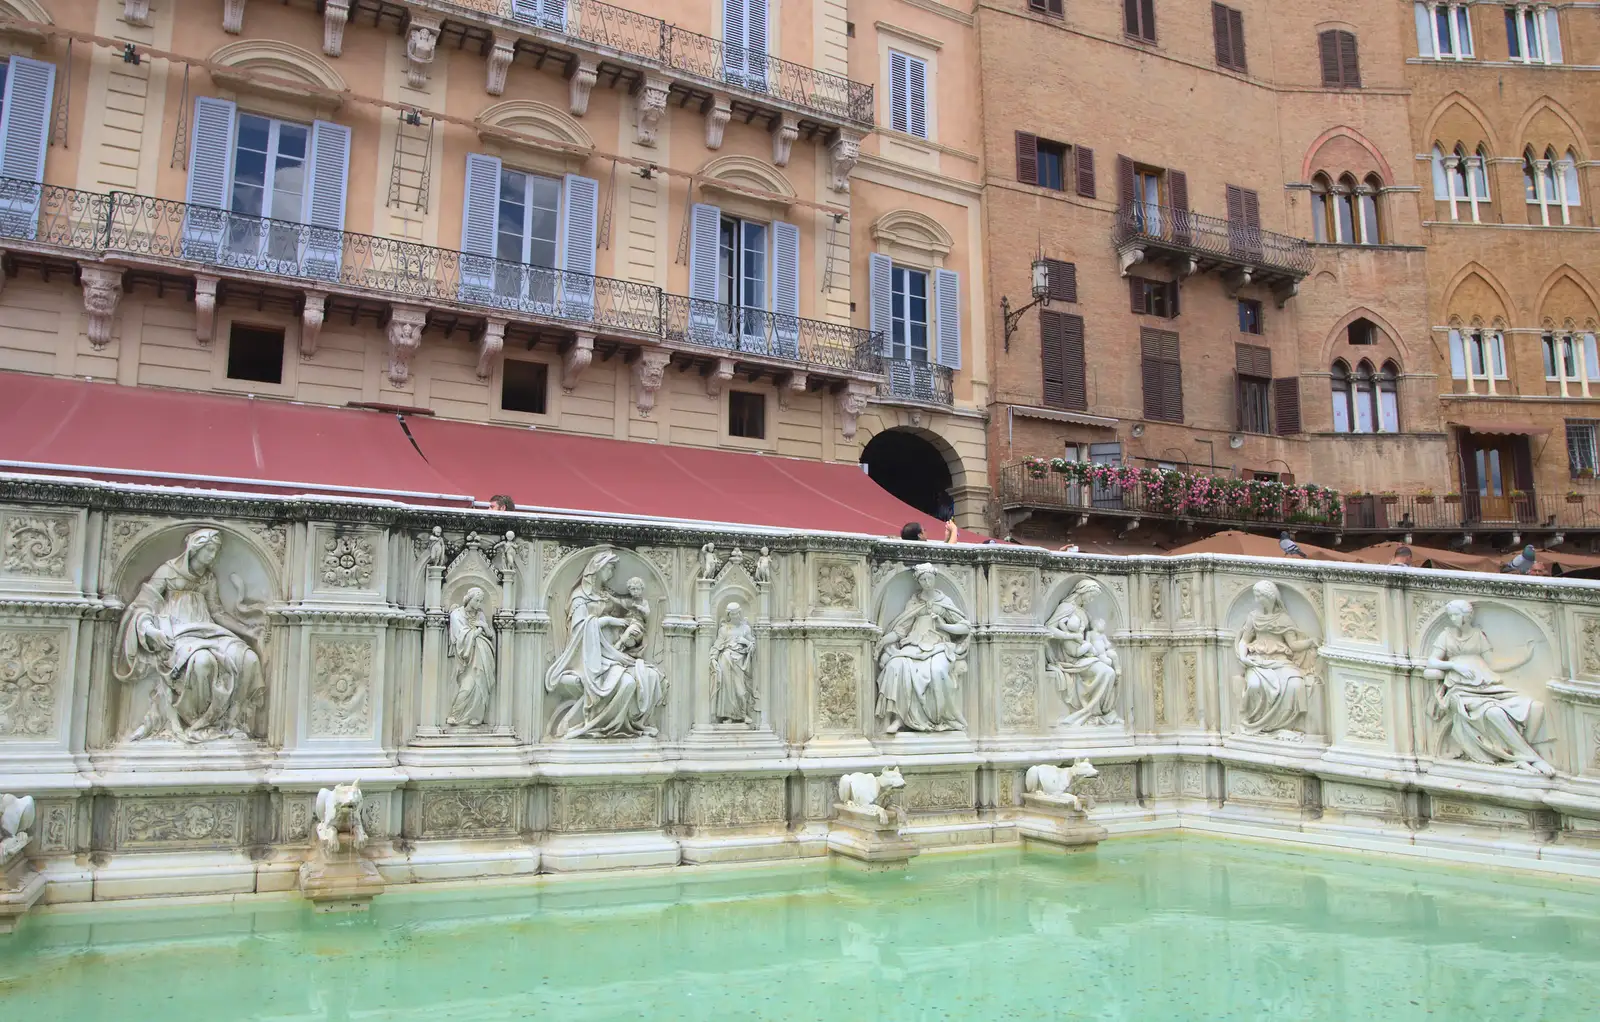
[0,373,953,541]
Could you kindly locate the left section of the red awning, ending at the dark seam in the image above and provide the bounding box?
[0,373,466,504]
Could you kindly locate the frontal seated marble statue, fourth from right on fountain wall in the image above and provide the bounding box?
[877,565,973,734]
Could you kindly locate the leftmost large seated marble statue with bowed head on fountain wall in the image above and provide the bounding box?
[112,529,266,742]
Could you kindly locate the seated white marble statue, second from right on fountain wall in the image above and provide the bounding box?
[1234,582,1317,741]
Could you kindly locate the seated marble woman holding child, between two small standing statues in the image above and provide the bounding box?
[544,550,666,739]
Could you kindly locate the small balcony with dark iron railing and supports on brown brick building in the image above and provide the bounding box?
[1112,203,1317,307]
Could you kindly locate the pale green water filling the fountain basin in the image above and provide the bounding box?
[0,838,1600,1022]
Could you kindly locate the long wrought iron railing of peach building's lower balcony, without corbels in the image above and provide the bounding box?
[0,178,883,374]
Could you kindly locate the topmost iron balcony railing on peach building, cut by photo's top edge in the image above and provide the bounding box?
[442,0,874,131]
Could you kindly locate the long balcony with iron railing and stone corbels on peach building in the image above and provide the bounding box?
[0,179,882,430]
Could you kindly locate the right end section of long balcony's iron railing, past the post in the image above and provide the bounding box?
[662,294,882,373]
